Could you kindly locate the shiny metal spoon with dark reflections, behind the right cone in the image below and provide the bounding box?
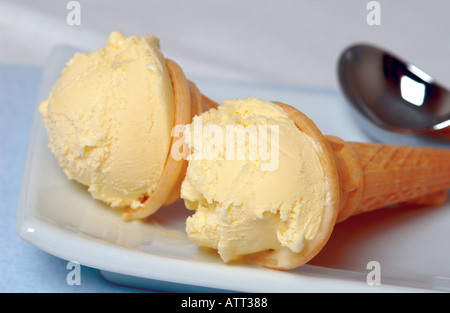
[338,44,450,147]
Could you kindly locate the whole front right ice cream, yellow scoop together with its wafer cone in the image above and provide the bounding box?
[181,98,450,269]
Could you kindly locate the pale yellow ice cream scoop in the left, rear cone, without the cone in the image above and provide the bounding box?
[39,31,174,208]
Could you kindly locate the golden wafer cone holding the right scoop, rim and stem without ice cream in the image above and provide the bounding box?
[248,102,450,269]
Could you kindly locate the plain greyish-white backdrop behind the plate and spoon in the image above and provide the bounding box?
[0,0,450,88]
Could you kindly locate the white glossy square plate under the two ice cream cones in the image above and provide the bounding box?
[17,47,450,292]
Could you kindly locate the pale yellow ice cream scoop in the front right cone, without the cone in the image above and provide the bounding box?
[181,98,326,262]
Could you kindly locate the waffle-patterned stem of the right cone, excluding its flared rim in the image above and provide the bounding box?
[327,137,450,222]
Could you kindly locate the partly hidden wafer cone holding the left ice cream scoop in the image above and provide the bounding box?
[122,59,217,220]
